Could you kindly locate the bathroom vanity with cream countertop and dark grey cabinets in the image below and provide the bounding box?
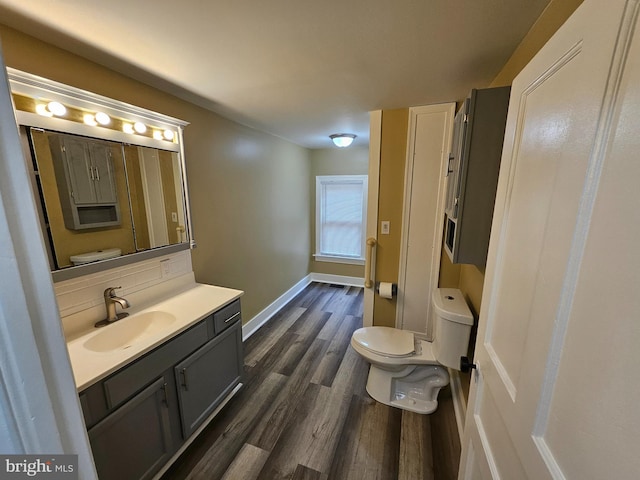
[68,284,243,480]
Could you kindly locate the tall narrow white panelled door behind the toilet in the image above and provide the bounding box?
[396,103,456,339]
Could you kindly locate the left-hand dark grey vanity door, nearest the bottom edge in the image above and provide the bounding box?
[89,377,172,480]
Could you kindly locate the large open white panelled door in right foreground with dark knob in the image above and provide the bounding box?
[459,0,640,480]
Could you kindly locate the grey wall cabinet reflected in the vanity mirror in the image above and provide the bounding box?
[49,135,120,230]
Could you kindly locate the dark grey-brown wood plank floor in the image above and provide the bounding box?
[162,283,460,480]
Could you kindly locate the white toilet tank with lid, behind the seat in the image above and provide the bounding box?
[431,288,473,370]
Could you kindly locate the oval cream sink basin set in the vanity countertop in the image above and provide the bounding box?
[83,311,176,352]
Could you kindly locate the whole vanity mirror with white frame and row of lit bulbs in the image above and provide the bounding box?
[7,68,195,281]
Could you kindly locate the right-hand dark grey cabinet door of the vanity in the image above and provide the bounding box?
[175,322,242,440]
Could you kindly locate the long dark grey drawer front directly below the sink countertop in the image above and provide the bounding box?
[104,321,207,409]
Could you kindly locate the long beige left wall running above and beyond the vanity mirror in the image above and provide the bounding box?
[0,25,310,321]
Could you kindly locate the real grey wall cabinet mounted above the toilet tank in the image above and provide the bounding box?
[445,87,511,268]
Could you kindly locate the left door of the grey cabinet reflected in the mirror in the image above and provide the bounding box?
[62,137,96,205]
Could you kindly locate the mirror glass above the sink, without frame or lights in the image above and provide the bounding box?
[23,128,189,270]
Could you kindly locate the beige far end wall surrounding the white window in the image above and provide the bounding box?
[309,145,369,278]
